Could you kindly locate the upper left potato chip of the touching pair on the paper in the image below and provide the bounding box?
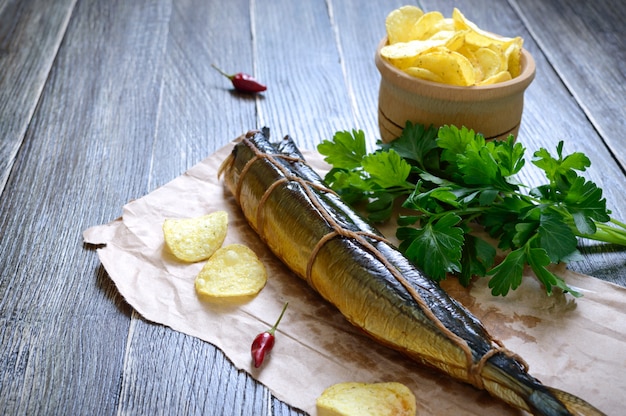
[163,211,228,263]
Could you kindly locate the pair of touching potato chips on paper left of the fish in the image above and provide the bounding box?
[163,211,267,298]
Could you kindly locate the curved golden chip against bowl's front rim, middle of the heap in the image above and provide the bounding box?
[417,50,476,86]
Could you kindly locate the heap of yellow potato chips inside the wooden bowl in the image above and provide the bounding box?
[380,6,523,86]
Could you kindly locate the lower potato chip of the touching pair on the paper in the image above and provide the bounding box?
[195,244,267,298]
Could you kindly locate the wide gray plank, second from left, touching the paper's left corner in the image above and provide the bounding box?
[0,2,169,414]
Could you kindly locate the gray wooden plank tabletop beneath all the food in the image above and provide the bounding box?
[0,0,626,415]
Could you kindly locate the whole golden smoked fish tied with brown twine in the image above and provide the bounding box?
[219,128,603,416]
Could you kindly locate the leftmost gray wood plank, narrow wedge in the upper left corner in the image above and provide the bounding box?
[0,0,75,193]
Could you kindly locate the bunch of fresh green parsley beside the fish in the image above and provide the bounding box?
[318,123,626,296]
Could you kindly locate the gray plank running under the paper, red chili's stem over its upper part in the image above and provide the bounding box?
[119,0,280,415]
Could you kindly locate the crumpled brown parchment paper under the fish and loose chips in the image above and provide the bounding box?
[83,144,626,415]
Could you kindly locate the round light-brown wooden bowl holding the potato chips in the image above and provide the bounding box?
[375,38,535,142]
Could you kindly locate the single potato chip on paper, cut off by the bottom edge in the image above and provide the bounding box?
[316,382,417,416]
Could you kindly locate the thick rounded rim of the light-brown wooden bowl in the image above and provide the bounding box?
[374,36,536,100]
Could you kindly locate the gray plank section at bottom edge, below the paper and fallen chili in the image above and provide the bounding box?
[119,314,270,415]
